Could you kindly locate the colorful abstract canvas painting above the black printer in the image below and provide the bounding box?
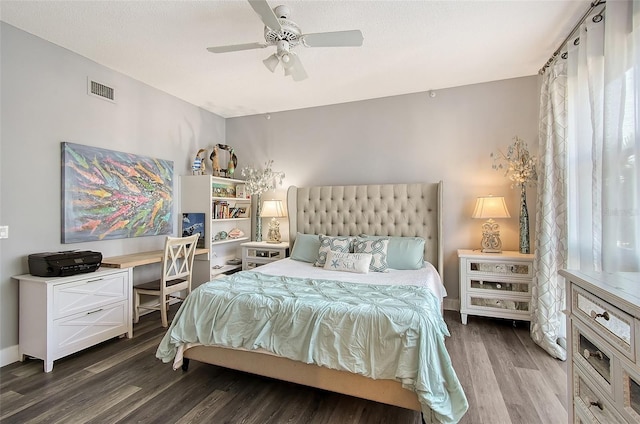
[61,142,173,243]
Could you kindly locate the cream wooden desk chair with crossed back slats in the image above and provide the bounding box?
[133,234,199,327]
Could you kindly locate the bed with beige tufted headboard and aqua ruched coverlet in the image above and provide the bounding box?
[156,182,468,423]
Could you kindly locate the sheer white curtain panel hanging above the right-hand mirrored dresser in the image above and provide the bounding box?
[567,1,640,272]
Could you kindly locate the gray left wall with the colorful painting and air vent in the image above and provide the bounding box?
[0,22,225,364]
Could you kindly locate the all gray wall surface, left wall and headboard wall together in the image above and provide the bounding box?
[0,23,539,365]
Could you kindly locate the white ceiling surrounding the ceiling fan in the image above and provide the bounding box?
[0,0,590,117]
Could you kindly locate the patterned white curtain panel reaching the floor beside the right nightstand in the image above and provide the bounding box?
[531,61,567,360]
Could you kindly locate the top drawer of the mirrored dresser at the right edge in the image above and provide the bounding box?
[571,285,636,362]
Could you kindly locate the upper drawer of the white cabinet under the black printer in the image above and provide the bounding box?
[53,272,129,319]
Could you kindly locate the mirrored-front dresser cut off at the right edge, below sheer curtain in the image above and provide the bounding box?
[560,270,640,424]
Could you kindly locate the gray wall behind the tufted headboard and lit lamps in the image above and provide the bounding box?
[227,76,539,308]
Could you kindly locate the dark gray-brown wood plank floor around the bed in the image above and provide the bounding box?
[0,311,567,424]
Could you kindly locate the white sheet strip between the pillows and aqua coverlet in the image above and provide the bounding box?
[252,258,447,304]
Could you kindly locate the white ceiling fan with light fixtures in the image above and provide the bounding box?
[207,0,363,81]
